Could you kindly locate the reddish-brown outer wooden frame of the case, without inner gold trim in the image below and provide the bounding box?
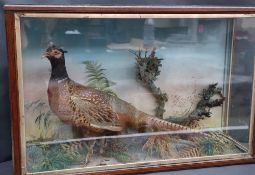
[4,5,255,175]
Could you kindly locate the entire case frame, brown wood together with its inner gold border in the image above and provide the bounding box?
[5,5,255,175]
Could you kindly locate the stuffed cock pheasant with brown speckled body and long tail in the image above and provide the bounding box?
[44,46,188,135]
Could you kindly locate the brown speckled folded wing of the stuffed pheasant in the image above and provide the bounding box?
[68,82,123,132]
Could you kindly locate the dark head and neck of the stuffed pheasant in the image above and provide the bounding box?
[43,45,68,80]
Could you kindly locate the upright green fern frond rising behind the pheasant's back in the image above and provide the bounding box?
[82,61,116,96]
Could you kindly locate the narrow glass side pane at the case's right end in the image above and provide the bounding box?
[228,18,255,145]
